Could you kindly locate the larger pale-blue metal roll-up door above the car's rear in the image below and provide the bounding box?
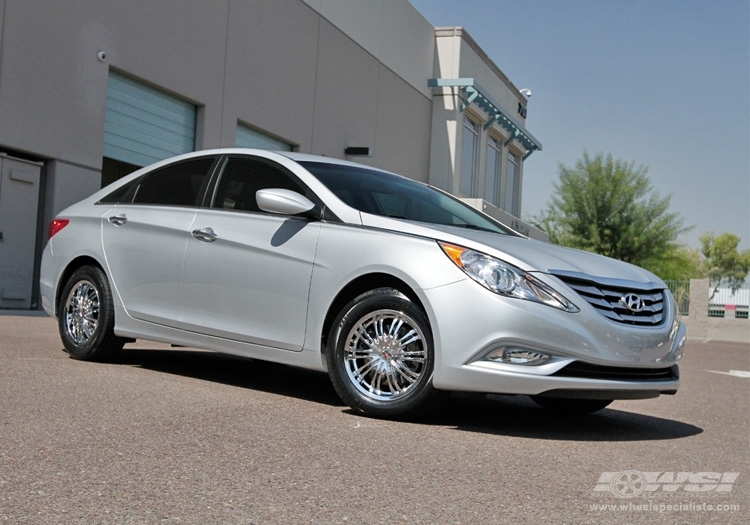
[104,72,196,166]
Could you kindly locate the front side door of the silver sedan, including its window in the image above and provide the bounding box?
[183,156,320,351]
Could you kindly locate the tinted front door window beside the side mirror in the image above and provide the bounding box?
[211,158,310,211]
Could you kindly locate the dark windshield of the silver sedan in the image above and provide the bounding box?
[300,162,513,235]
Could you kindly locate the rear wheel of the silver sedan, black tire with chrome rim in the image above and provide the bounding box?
[57,266,125,361]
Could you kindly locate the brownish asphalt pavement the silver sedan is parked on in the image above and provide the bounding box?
[0,315,750,525]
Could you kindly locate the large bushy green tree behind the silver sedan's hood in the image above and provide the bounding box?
[531,152,694,278]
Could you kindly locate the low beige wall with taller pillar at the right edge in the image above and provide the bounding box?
[682,279,750,343]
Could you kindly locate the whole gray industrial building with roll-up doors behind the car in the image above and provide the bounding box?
[0,0,545,309]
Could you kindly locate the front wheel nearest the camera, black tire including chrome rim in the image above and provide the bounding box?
[326,288,439,420]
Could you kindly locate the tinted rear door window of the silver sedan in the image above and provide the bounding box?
[133,157,214,206]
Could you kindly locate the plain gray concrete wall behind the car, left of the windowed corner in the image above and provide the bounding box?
[0,0,434,205]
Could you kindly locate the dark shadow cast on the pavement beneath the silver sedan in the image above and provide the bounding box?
[116,348,703,441]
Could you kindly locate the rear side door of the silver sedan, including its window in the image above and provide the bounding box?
[102,156,215,326]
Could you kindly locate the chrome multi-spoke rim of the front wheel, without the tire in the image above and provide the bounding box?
[344,310,427,401]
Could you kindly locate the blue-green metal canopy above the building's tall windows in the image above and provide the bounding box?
[427,78,542,159]
